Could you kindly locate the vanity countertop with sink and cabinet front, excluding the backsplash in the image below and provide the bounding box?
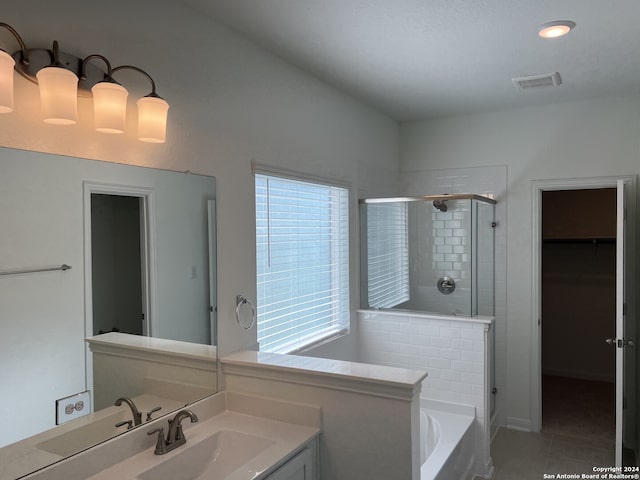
[85,411,318,480]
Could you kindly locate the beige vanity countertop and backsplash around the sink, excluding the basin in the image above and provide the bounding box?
[20,392,322,480]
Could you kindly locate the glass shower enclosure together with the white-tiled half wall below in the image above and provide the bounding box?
[357,194,499,478]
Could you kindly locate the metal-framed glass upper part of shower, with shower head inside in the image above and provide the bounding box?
[360,194,496,317]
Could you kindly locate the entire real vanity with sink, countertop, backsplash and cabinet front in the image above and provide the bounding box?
[21,392,321,480]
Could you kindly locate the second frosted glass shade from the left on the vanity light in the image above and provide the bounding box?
[36,67,78,125]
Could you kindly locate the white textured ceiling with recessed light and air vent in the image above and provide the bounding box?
[184,0,640,121]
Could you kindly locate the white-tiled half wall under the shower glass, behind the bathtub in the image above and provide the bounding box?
[358,310,493,476]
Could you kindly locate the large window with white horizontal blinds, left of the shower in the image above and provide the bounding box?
[255,174,349,353]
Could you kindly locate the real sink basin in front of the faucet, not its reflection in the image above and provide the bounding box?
[136,430,274,480]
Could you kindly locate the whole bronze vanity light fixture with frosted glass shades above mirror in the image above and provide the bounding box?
[0,22,169,143]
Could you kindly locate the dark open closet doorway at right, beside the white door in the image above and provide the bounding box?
[541,188,616,454]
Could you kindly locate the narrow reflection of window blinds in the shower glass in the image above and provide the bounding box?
[367,203,409,308]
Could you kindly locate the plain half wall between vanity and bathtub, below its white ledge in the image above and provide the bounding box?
[222,361,420,480]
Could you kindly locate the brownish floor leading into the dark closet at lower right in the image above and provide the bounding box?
[491,377,615,480]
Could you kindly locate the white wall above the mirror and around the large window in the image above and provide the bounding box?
[0,0,398,364]
